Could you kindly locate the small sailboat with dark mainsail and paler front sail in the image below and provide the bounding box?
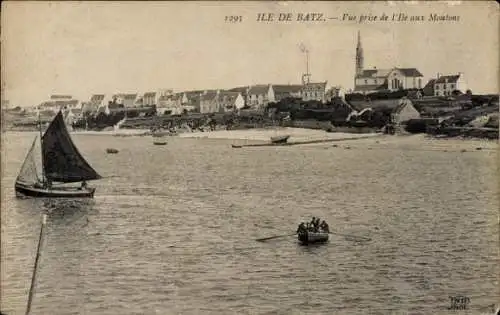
[15,111,102,198]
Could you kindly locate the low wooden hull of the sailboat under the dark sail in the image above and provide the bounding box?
[15,183,95,198]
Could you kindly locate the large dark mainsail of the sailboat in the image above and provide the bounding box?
[42,111,101,183]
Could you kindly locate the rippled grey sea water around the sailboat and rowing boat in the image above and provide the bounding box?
[0,134,500,315]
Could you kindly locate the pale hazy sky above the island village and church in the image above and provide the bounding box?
[1,1,499,106]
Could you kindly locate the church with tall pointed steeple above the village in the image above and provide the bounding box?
[354,31,424,94]
